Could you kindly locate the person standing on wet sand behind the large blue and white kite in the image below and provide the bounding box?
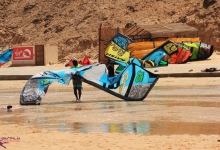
[71,58,82,101]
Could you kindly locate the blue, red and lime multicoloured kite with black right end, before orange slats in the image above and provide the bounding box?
[138,40,214,67]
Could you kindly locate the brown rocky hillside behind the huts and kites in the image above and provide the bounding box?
[0,0,220,59]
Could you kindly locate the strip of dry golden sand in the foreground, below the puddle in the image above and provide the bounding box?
[0,125,220,150]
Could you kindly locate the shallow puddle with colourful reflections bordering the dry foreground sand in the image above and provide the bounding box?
[3,109,220,135]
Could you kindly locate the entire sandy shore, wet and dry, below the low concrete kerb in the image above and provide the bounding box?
[0,78,220,150]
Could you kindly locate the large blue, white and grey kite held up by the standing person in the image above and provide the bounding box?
[20,63,159,105]
